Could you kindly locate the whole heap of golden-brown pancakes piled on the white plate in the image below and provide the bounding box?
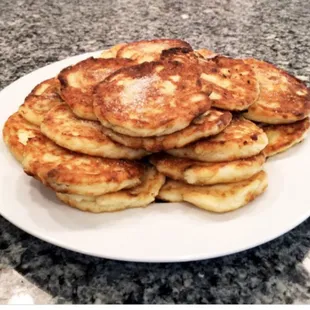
[3,39,310,212]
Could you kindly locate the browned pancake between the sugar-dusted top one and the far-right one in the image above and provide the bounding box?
[200,56,259,111]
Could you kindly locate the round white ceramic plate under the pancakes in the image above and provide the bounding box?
[0,53,310,262]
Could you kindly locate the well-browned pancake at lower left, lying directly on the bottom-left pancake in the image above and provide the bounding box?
[22,134,144,196]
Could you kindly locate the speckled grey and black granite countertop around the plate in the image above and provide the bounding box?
[0,0,310,303]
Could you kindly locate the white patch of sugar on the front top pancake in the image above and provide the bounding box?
[120,75,156,109]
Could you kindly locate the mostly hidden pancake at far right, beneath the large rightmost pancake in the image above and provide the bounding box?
[262,118,310,157]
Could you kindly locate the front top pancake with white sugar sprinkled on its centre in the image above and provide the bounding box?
[94,61,210,137]
